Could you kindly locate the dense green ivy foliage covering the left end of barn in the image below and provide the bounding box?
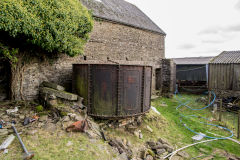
[0,0,93,62]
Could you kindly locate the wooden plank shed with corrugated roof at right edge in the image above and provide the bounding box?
[209,51,240,98]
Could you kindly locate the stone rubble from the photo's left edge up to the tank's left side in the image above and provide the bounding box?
[0,82,101,138]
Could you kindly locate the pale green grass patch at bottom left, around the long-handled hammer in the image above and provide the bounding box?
[0,130,115,160]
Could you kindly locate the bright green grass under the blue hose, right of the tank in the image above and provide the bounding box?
[152,94,240,159]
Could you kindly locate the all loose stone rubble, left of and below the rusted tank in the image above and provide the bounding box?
[0,82,239,160]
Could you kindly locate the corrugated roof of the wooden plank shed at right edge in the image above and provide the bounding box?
[210,51,240,64]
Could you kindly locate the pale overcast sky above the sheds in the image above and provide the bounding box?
[127,0,240,58]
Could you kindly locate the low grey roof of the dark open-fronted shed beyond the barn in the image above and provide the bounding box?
[173,57,213,65]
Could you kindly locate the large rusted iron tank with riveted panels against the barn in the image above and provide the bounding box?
[73,64,152,119]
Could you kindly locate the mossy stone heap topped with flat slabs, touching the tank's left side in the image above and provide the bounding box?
[40,82,102,138]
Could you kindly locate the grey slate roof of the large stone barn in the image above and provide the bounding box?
[80,0,166,35]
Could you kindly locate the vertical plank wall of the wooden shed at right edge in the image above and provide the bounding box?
[209,64,240,97]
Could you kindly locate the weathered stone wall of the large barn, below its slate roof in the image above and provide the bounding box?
[12,21,165,100]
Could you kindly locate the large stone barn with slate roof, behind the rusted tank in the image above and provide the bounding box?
[0,0,169,100]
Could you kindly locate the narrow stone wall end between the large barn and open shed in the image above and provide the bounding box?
[162,59,176,96]
